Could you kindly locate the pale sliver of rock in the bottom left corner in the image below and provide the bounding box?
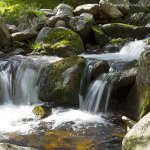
[0,143,37,150]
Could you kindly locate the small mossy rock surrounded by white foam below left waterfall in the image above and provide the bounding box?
[32,105,52,119]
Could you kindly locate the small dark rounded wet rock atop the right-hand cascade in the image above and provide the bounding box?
[92,60,109,78]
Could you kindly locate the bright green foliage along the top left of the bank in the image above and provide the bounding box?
[0,0,98,24]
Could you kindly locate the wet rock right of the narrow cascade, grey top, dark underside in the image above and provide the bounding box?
[115,68,137,88]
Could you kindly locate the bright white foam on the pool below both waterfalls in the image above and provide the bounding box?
[0,105,106,134]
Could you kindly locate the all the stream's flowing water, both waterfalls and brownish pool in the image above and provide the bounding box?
[0,41,146,150]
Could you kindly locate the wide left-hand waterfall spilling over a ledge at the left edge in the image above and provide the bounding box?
[0,56,60,104]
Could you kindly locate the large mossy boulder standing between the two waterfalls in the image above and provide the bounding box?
[40,56,85,107]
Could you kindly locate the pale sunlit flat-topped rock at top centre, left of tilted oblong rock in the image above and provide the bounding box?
[74,4,101,17]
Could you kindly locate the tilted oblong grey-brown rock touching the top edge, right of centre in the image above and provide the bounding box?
[99,0,123,19]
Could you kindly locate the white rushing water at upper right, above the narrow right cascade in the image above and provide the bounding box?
[81,40,147,61]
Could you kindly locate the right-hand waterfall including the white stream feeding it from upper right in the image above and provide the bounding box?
[80,40,147,113]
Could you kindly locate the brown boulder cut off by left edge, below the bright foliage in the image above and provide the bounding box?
[0,18,11,46]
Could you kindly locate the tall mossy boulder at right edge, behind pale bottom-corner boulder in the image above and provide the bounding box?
[137,50,150,117]
